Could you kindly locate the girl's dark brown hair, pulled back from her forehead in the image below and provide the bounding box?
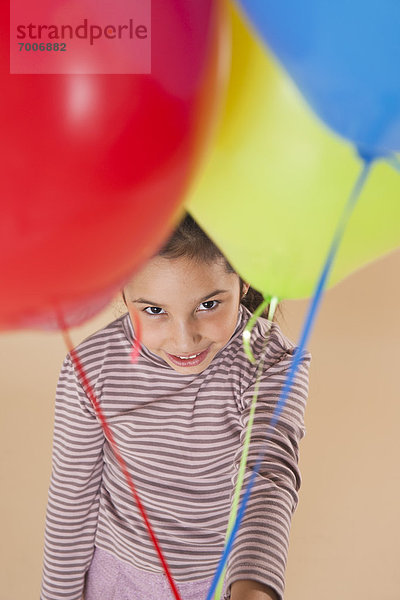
[157,213,280,317]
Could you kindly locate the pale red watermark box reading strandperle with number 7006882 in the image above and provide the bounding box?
[10,0,151,75]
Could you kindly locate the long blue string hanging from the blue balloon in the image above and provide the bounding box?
[207,160,372,600]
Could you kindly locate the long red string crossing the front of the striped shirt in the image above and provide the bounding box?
[59,316,182,600]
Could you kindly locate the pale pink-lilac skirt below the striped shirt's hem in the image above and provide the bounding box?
[84,548,229,600]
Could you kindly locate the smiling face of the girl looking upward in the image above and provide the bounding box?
[124,256,247,375]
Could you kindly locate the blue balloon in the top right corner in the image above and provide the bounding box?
[238,0,400,158]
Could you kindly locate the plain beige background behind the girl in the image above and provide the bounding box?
[0,252,400,600]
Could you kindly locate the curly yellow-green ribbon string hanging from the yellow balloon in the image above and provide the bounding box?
[214,296,278,600]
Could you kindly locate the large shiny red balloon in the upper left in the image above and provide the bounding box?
[0,0,226,329]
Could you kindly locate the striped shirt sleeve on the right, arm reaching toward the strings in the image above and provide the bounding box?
[227,336,311,599]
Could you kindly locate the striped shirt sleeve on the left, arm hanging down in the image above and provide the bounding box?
[40,356,104,600]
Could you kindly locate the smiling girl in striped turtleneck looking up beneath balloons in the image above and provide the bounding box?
[41,215,310,600]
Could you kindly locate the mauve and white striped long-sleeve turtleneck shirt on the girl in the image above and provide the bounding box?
[41,306,310,600]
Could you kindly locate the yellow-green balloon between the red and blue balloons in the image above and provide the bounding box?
[186,1,400,298]
